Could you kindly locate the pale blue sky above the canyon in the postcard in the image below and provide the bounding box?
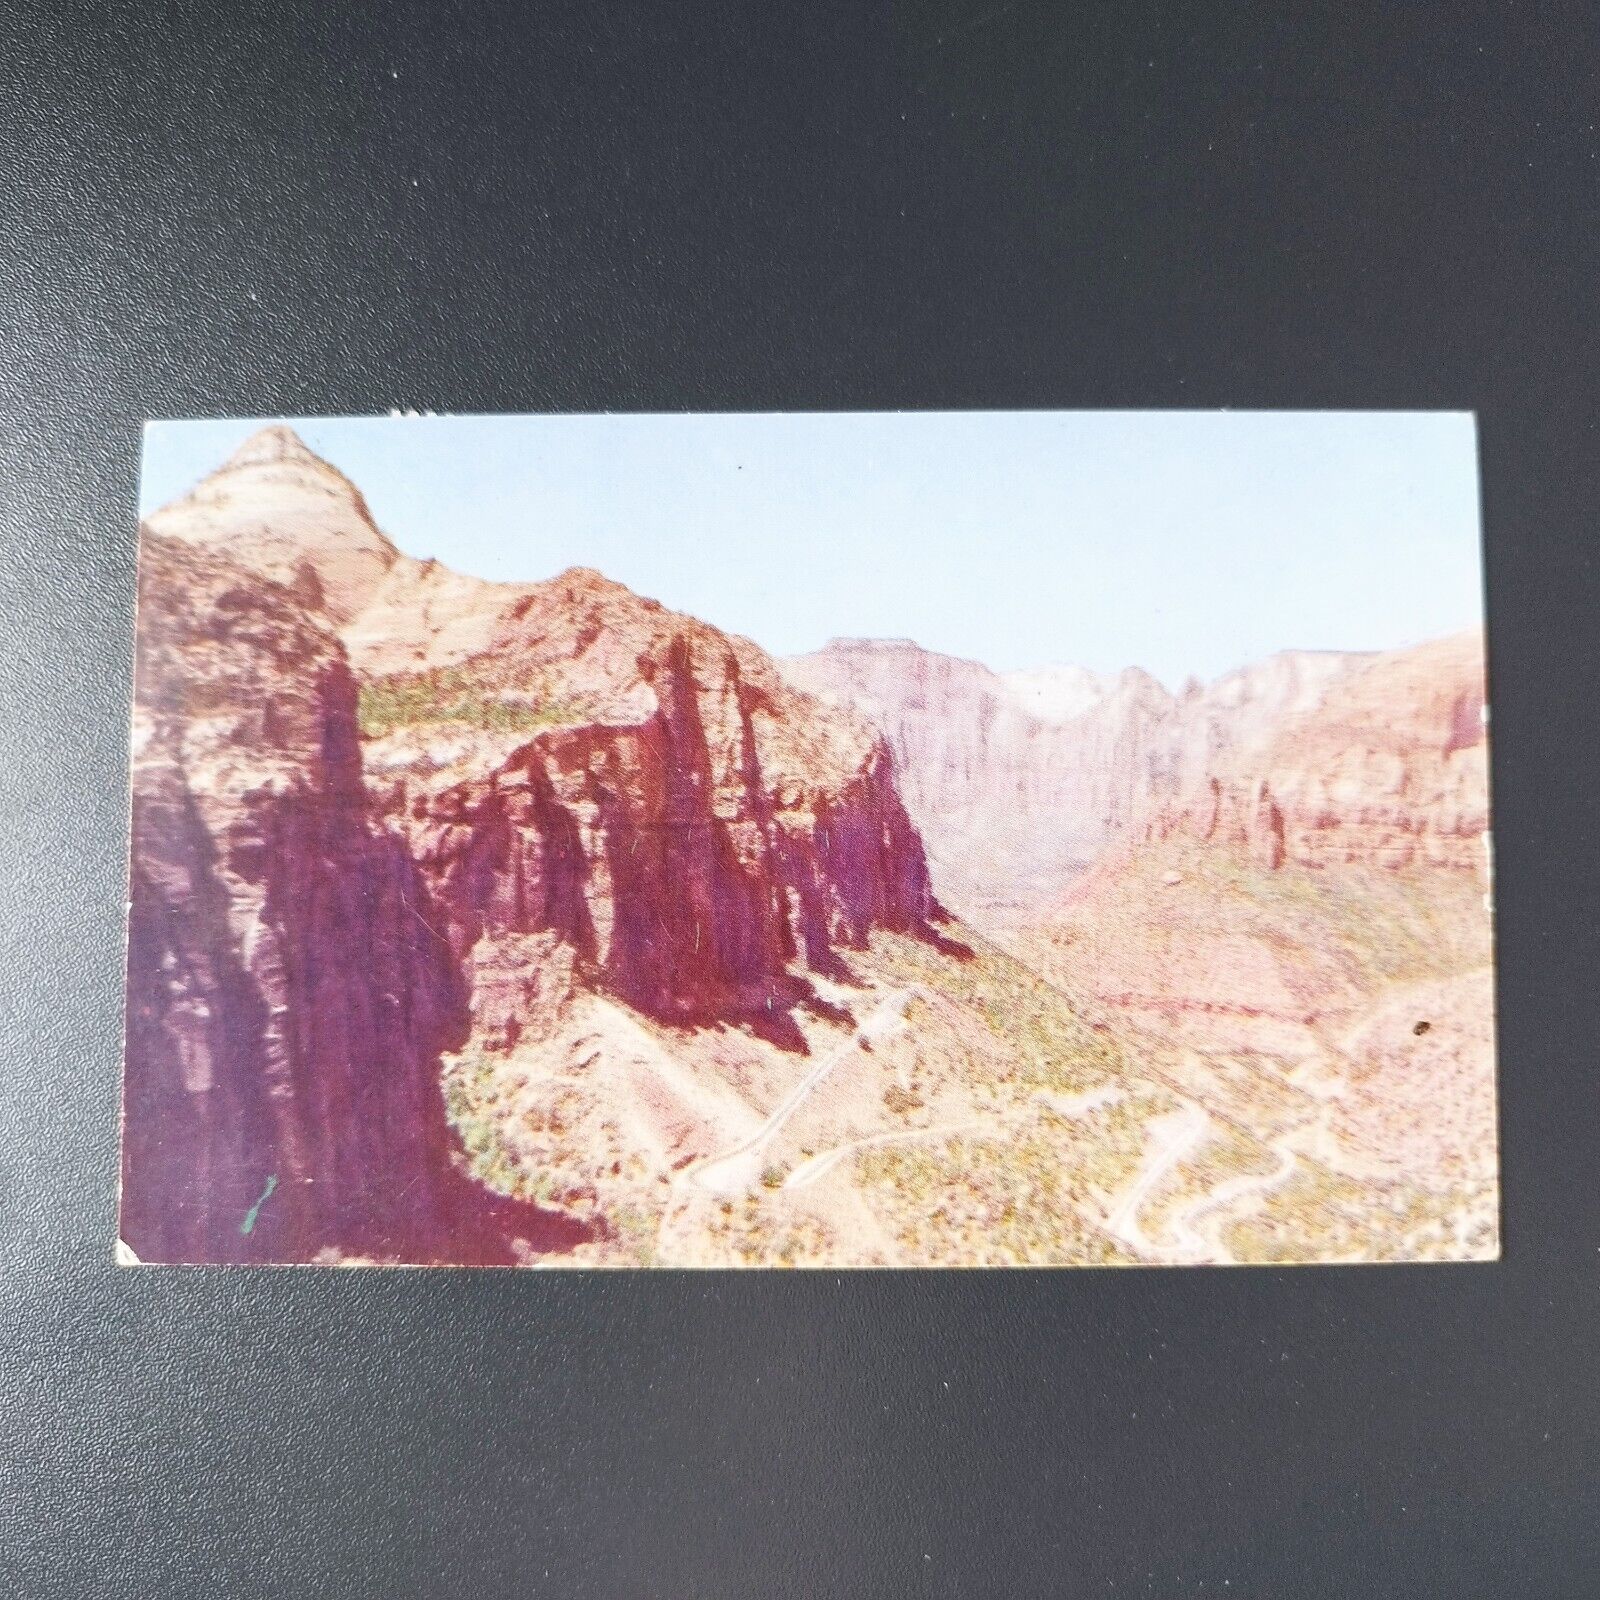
[141,411,1482,686]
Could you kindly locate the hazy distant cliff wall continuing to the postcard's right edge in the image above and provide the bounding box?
[784,632,1488,923]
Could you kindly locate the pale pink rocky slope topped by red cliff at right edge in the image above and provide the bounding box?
[1006,632,1498,1261]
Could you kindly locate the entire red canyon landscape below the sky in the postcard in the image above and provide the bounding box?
[122,427,1498,1266]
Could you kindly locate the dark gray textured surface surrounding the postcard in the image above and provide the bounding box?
[0,0,1600,1600]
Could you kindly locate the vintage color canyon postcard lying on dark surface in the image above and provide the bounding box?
[118,413,1499,1267]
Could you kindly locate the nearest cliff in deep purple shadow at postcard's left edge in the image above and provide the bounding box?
[122,534,556,1261]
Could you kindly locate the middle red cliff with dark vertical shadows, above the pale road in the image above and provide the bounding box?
[368,573,939,1043]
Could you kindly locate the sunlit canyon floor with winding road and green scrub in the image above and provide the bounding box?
[432,853,1498,1267]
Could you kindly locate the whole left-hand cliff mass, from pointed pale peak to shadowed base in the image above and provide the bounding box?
[123,429,941,1259]
